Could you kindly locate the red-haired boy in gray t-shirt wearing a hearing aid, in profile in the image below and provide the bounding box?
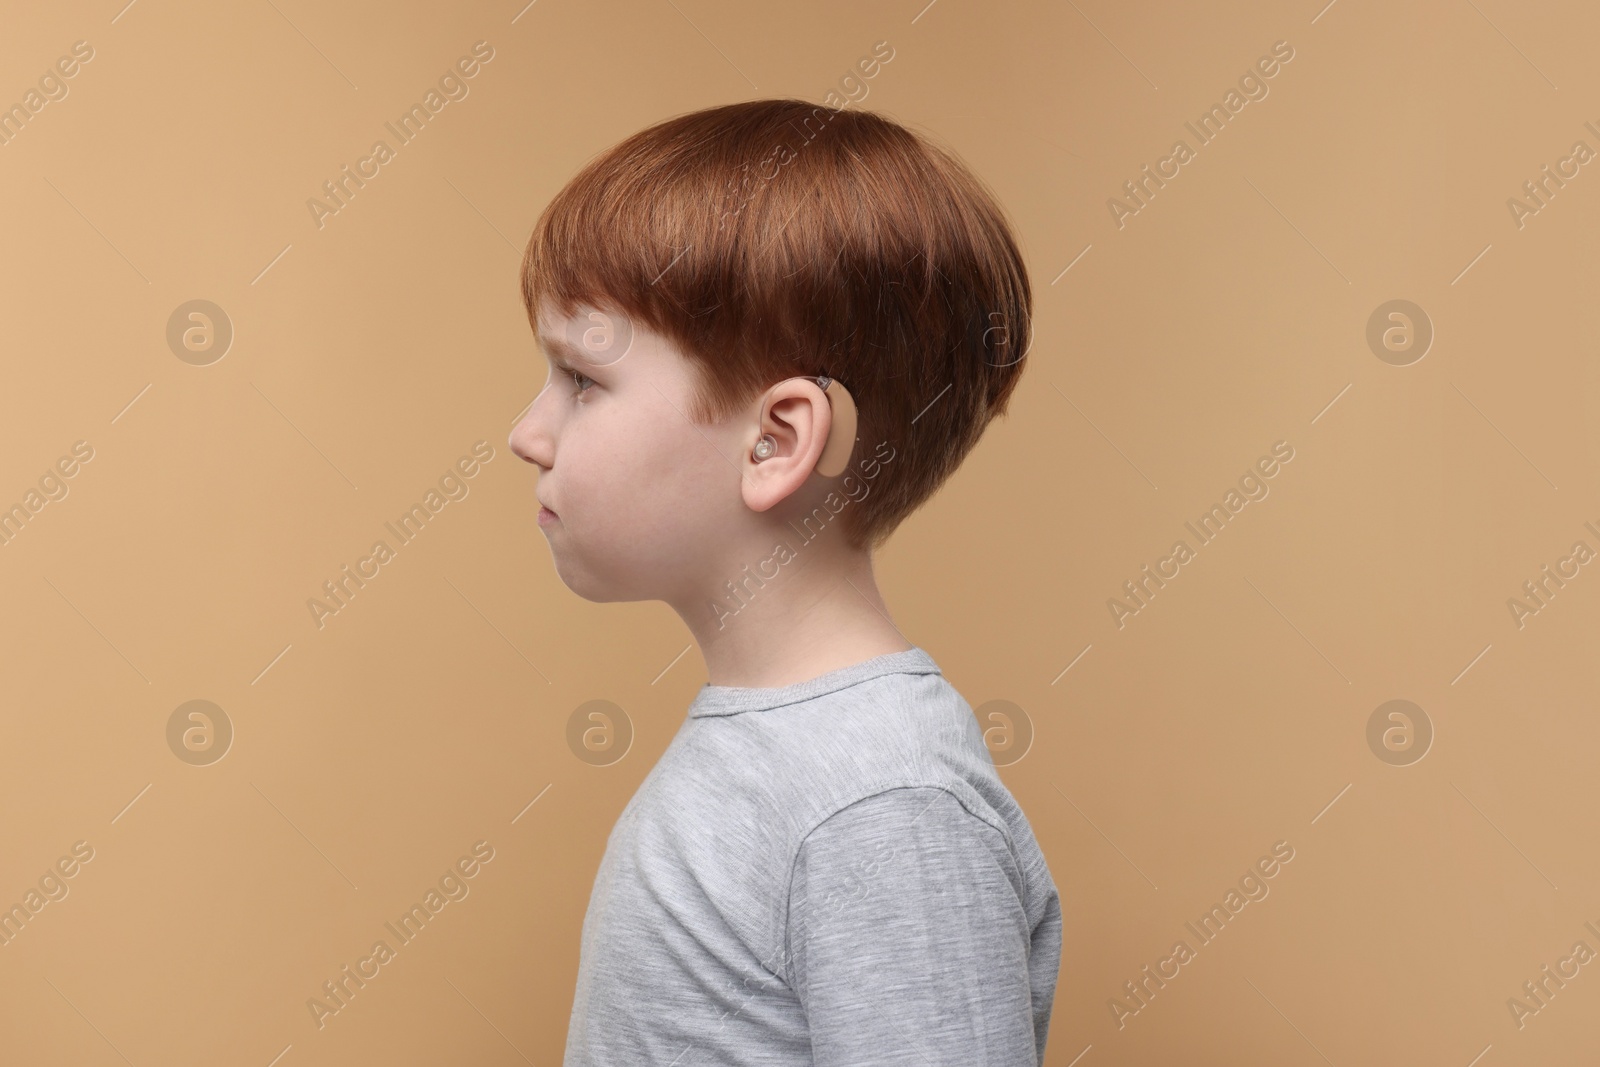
[510,99,1061,1067]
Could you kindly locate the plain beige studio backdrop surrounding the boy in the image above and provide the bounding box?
[0,0,1600,1067]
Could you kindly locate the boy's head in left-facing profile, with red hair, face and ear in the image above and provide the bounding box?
[510,99,1032,600]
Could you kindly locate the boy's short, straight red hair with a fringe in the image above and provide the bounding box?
[522,99,1032,549]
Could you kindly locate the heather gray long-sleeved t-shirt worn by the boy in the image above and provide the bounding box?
[563,648,1061,1067]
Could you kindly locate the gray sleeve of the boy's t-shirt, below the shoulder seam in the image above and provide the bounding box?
[786,787,1043,1067]
